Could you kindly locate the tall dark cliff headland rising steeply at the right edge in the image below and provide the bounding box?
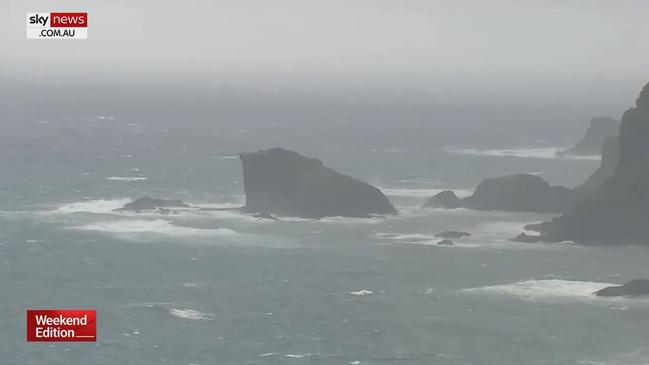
[538,84,649,245]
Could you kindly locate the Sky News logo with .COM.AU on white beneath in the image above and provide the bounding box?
[27,12,88,39]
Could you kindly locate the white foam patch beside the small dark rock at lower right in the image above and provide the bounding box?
[462,279,616,301]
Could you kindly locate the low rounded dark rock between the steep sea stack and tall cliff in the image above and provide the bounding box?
[423,174,579,213]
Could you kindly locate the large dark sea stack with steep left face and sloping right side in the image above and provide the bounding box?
[240,148,397,218]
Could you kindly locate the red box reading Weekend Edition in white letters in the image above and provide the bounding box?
[27,309,97,342]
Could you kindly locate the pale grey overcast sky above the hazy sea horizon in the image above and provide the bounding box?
[0,0,649,79]
